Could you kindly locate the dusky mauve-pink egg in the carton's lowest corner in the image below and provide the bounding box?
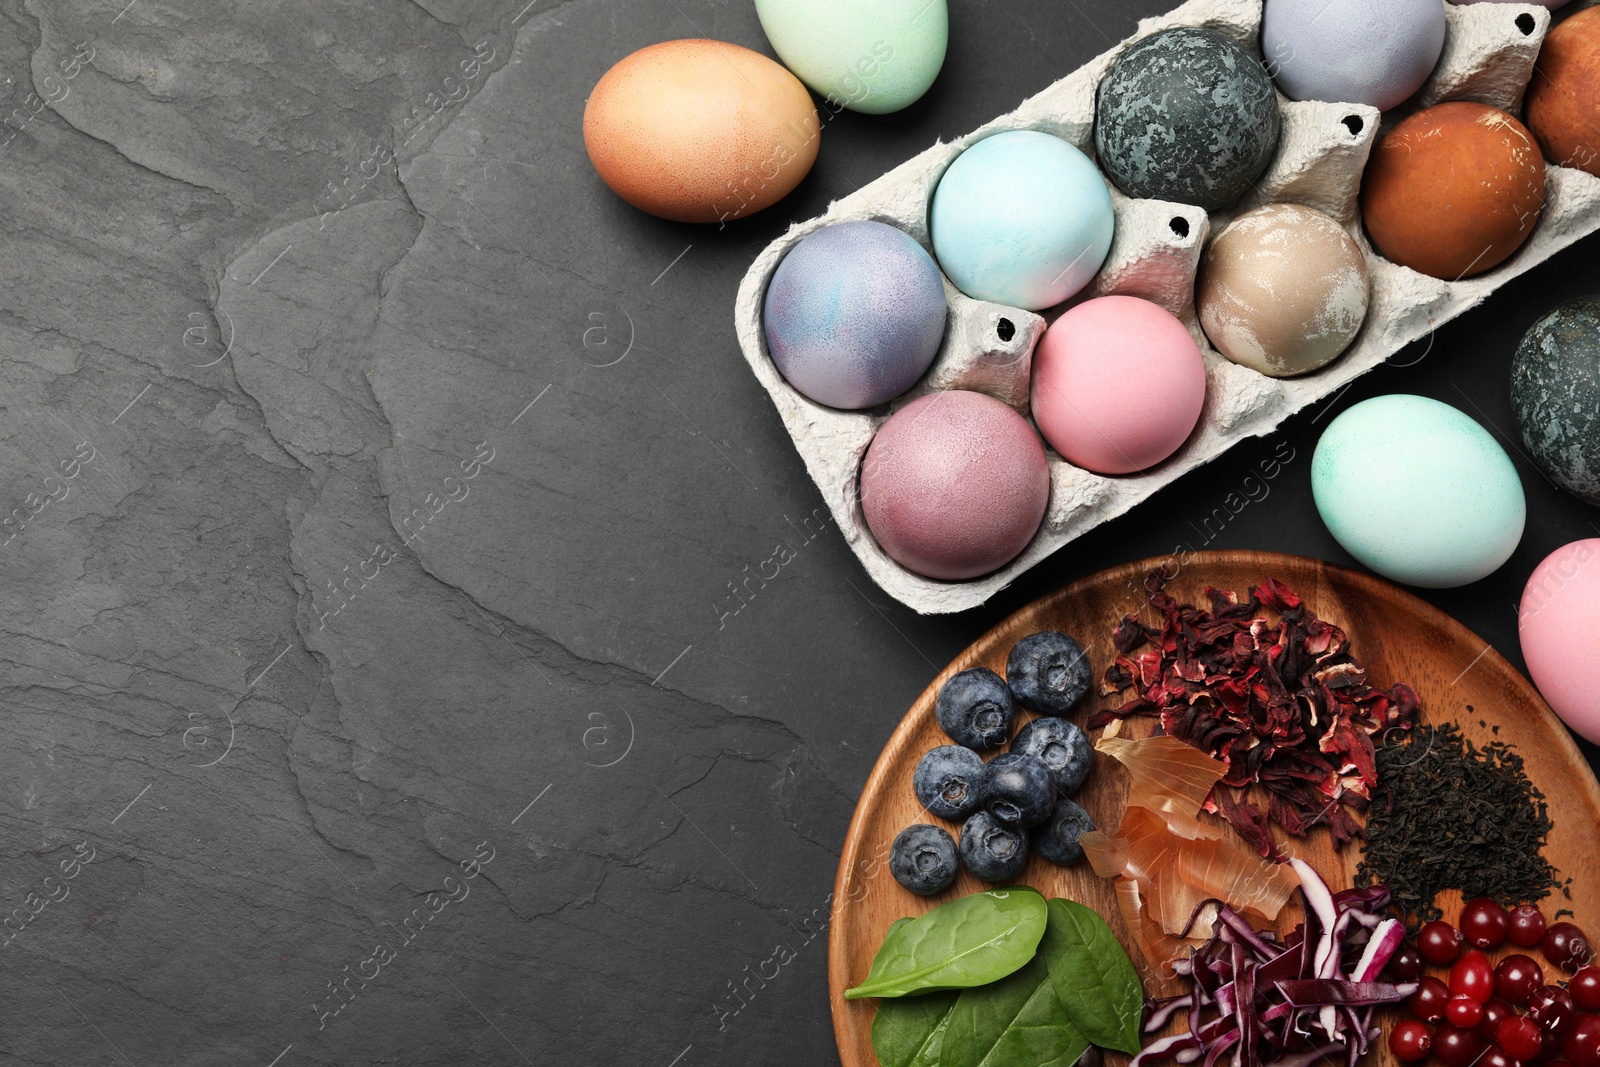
[861,389,1050,581]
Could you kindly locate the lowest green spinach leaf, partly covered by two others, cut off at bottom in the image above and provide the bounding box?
[939,929,1090,1067]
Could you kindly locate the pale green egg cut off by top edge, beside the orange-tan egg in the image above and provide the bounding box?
[755,0,950,115]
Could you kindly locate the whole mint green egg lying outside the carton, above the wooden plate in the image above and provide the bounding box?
[1310,394,1528,589]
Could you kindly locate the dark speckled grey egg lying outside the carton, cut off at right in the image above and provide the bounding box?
[1510,296,1600,506]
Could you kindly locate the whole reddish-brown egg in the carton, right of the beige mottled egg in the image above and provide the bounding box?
[1362,101,1544,282]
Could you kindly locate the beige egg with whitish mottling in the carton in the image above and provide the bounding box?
[1195,203,1368,378]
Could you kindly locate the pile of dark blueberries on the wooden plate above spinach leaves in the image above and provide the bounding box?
[890,630,1094,896]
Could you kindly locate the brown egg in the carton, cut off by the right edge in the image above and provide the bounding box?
[1523,8,1600,176]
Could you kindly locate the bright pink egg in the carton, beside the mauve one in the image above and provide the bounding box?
[1034,296,1205,474]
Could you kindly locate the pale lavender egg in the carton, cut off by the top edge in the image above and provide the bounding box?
[1261,0,1445,110]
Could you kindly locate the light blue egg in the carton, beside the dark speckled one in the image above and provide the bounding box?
[928,130,1115,310]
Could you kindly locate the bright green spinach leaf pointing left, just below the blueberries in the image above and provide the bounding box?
[845,886,1050,1000]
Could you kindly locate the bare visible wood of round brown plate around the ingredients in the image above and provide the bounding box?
[827,552,1600,1067]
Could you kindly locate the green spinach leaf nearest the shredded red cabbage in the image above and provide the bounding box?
[1042,901,1144,1056]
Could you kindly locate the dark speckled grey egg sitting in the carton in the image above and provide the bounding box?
[1094,26,1280,211]
